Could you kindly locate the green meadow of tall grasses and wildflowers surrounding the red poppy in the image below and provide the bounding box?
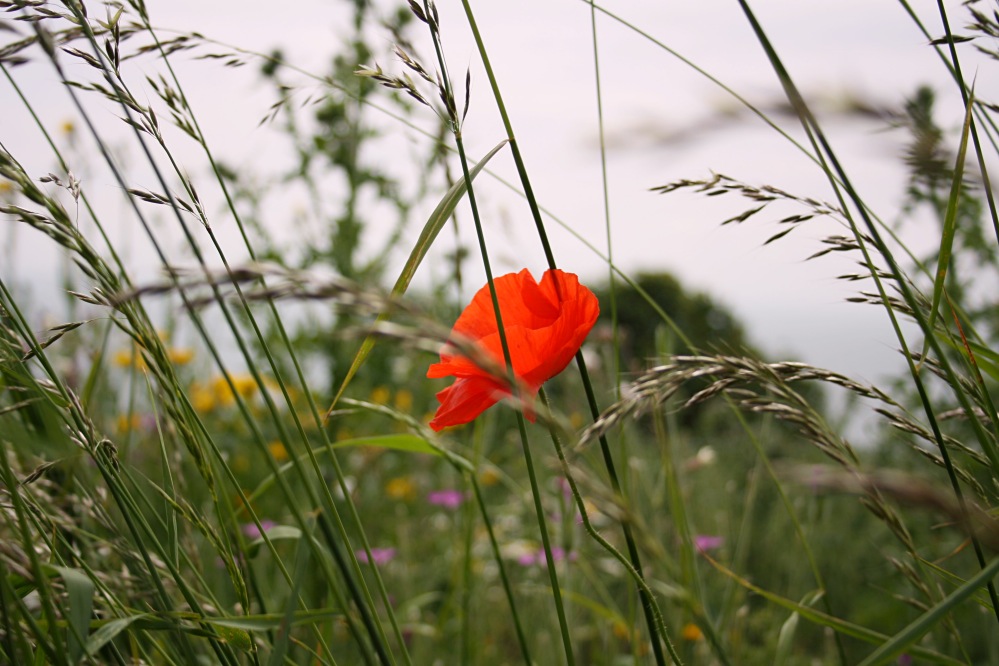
[0,0,999,666]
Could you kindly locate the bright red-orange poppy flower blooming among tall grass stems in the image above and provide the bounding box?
[427,268,600,430]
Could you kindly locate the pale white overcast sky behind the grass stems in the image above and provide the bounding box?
[0,0,994,400]
